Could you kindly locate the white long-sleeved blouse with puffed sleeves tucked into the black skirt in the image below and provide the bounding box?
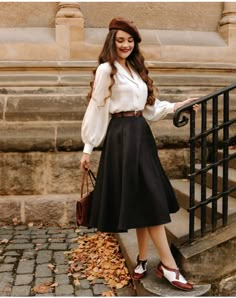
[81,61,175,154]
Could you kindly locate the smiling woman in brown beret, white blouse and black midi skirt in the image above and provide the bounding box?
[81,18,197,290]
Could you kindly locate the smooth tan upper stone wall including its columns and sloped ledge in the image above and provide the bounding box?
[0,2,236,63]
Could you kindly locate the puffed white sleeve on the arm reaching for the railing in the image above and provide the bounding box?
[143,99,175,121]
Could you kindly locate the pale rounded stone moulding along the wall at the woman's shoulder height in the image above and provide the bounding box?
[0,67,235,88]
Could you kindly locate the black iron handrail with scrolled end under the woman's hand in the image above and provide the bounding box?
[173,83,236,127]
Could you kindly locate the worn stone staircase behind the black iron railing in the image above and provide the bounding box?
[117,149,236,297]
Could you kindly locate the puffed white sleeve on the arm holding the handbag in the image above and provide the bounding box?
[81,63,111,154]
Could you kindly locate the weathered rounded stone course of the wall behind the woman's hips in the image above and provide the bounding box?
[0,117,234,154]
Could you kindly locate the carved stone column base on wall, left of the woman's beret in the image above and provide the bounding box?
[56,2,84,56]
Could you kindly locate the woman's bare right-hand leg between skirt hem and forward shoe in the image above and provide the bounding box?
[147,225,177,269]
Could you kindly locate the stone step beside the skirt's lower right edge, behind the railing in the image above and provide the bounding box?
[171,179,236,228]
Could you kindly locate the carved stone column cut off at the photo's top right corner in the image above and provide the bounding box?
[219,2,236,46]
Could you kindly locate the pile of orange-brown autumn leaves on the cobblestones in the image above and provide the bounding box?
[68,232,130,296]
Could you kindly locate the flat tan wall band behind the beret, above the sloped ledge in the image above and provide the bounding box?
[0,2,223,31]
